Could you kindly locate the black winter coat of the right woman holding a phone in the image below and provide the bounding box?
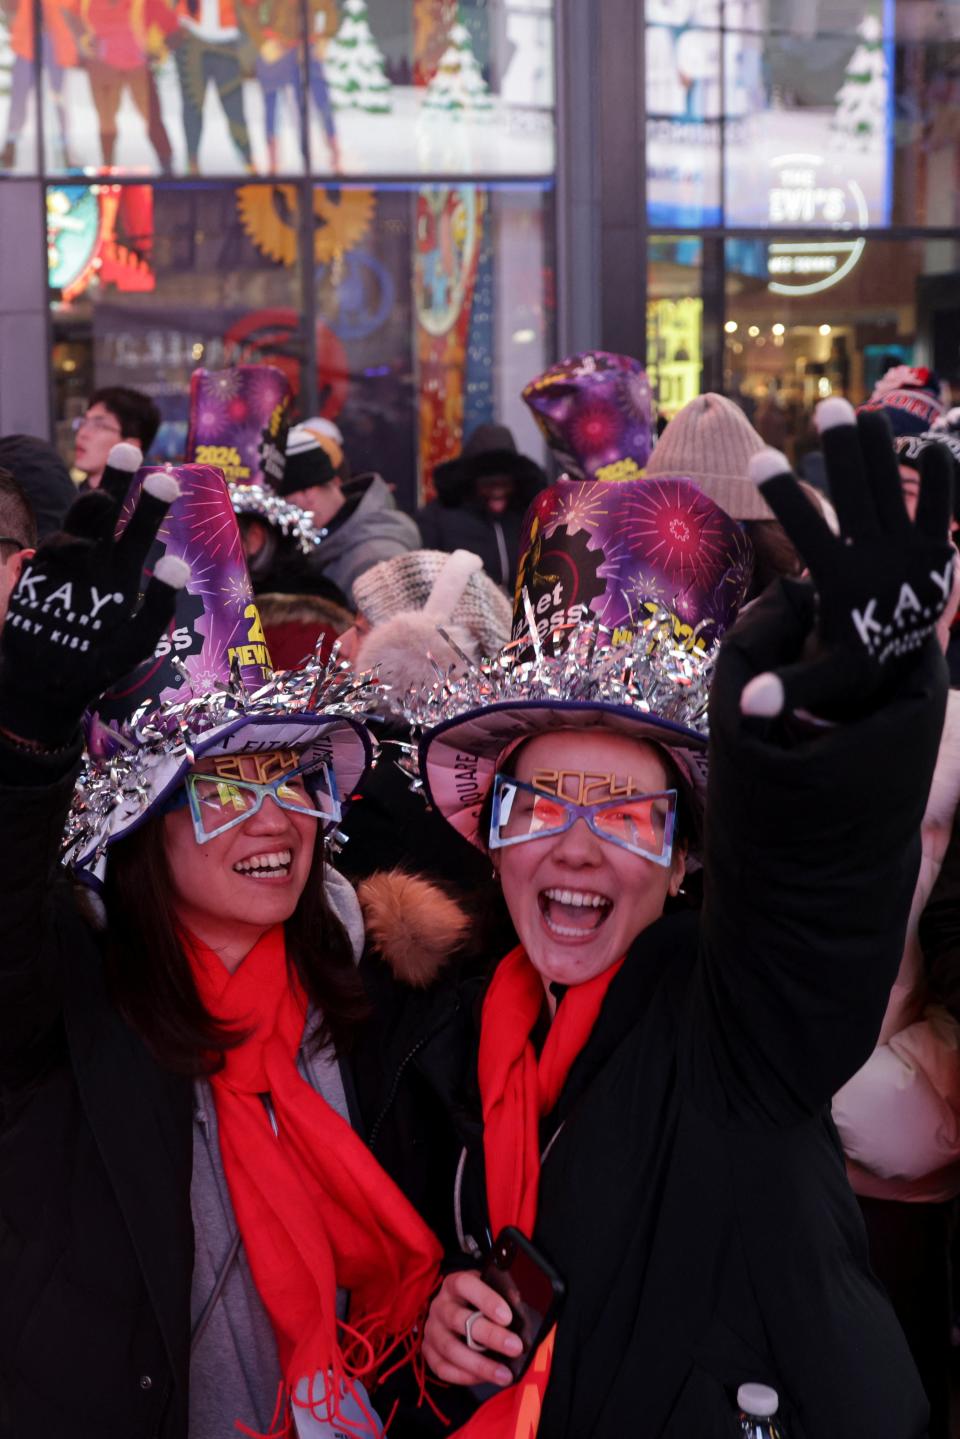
[351,589,946,1439]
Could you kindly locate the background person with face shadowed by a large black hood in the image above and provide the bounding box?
[417,425,547,596]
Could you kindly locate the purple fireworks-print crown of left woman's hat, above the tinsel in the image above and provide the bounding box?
[88,465,271,757]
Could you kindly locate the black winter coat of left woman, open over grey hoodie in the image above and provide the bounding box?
[0,741,462,1439]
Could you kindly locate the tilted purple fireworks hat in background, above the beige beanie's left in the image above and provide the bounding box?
[524,350,653,481]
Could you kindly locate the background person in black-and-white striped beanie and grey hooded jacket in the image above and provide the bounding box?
[272,425,420,606]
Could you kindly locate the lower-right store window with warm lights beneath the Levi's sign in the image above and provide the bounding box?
[724,237,960,469]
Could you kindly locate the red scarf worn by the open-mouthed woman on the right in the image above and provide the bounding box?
[456,948,623,1439]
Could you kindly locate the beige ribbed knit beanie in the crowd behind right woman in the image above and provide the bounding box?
[645,394,773,519]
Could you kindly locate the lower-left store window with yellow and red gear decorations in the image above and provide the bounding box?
[47,181,554,509]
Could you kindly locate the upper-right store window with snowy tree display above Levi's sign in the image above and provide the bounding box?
[645,0,960,230]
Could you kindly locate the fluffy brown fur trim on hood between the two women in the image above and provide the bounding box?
[357,869,471,989]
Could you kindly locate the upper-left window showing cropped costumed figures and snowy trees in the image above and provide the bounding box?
[0,0,554,177]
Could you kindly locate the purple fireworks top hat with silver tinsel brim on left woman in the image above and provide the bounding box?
[65,465,376,881]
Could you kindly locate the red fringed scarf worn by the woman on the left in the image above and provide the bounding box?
[186,925,440,1433]
